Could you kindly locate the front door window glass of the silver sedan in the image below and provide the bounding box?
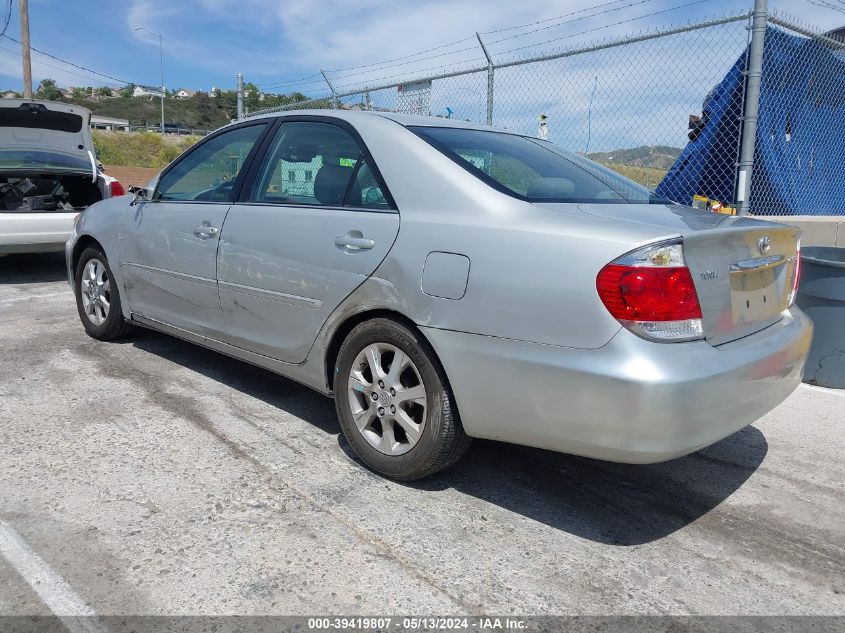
[154,124,265,202]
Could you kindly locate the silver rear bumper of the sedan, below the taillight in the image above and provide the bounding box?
[422,307,812,463]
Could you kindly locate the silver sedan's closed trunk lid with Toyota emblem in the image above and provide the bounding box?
[581,204,801,345]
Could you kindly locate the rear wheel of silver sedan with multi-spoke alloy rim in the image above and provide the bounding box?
[334,319,470,481]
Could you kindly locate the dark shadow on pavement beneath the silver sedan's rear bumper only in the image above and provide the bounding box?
[407,426,768,546]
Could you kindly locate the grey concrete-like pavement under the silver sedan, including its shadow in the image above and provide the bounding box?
[0,255,845,615]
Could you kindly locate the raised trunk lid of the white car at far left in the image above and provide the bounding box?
[0,99,94,174]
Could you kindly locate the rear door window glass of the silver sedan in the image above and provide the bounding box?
[249,121,388,208]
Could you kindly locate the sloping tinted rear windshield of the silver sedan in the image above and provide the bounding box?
[410,127,670,204]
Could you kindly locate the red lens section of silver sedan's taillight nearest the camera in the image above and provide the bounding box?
[596,264,701,321]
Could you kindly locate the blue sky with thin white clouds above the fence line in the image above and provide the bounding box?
[0,0,845,95]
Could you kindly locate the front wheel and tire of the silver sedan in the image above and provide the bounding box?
[73,247,135,341]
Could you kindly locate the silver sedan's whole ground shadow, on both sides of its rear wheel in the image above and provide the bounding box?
[128,330,768,546]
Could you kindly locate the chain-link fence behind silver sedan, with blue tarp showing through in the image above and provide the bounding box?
[250,12,845,215]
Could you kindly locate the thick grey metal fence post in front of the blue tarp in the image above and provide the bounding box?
[736,0,768,215]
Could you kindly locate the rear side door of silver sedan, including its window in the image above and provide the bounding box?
[217,118,399,363]
